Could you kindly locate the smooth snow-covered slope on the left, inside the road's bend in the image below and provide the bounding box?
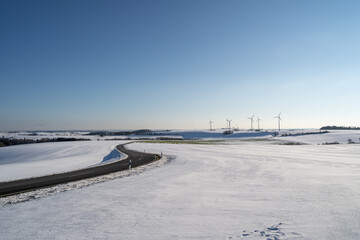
[0,141,126,182]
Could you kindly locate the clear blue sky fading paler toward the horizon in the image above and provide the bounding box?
[0,0,360,131]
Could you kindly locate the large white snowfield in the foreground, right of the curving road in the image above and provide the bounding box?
[0,142,360,240]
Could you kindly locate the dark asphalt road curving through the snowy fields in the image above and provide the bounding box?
[0,143,161,197]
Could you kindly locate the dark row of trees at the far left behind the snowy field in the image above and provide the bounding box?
[0,137,90,147]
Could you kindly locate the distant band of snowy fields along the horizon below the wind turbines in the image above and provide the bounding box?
[0,129,360,144]
